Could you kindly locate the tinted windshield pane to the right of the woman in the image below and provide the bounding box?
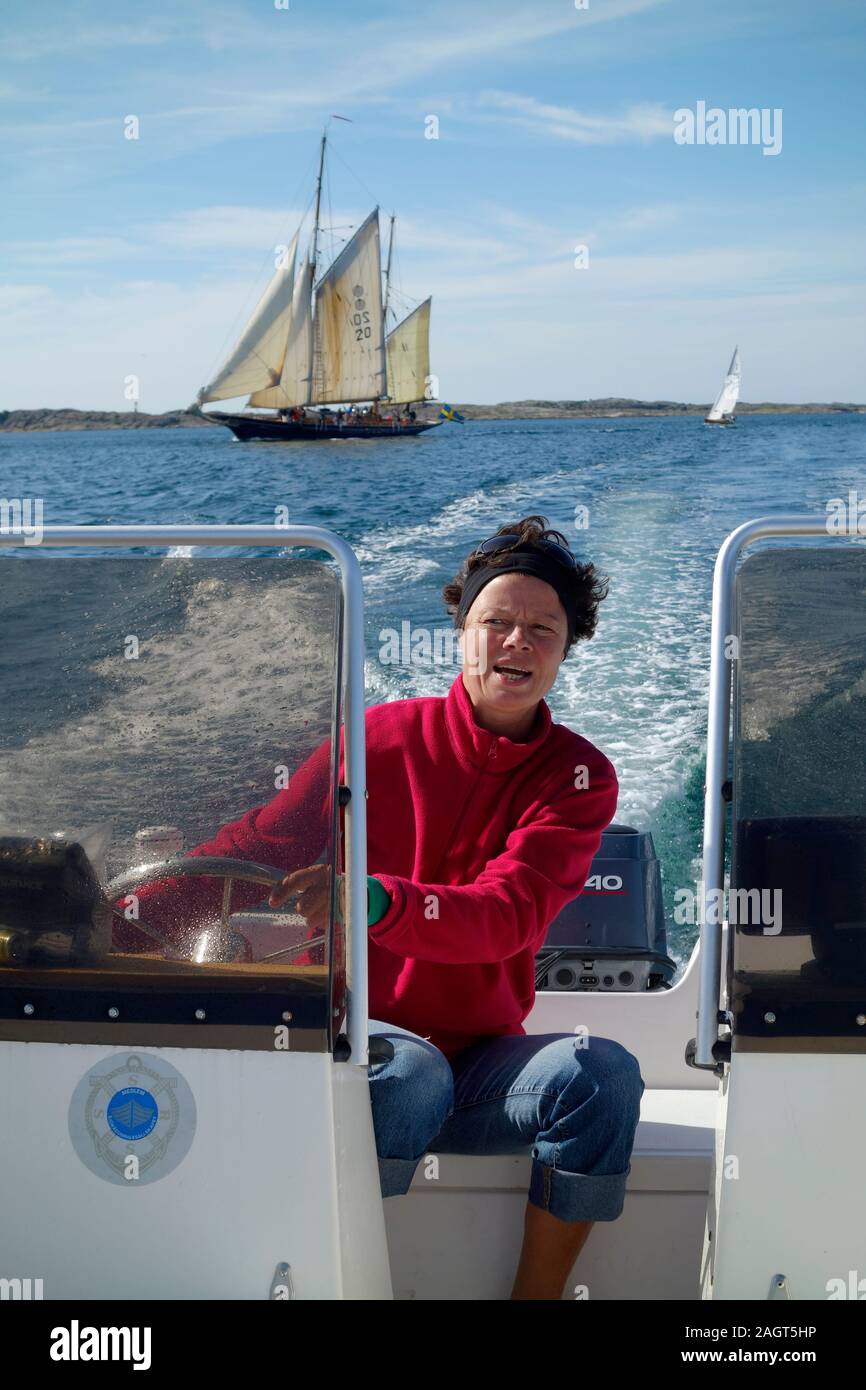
[728,543,866,1045]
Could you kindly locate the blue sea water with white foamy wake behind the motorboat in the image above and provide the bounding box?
[0,414,866,959]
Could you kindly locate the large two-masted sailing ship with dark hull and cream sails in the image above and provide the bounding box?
[196,131,439,441]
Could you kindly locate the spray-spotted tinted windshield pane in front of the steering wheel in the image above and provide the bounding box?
[0,549,345,1041]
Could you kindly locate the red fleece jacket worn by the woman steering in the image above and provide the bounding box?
[125,676,619,1056]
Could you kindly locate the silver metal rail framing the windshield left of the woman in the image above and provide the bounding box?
[0,525,368,1068]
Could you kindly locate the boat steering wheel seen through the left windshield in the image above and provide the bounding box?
[106,855,325,965]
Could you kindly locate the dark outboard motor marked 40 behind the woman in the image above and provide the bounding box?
[535,823,677,991]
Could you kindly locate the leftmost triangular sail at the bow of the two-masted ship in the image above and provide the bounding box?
[199,234,297,404]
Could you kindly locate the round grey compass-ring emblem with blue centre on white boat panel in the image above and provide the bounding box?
[70,1052,196,1187]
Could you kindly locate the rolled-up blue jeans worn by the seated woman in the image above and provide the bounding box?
[368,1019,645,1220]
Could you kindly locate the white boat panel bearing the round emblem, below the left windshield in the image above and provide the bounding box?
[0,1043,391,1301]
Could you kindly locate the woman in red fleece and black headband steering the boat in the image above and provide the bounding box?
[120,516,644,1298]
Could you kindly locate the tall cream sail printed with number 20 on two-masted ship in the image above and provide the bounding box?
[311,207,385,404]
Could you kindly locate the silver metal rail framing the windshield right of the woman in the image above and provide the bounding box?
[694,513,853,1070]
